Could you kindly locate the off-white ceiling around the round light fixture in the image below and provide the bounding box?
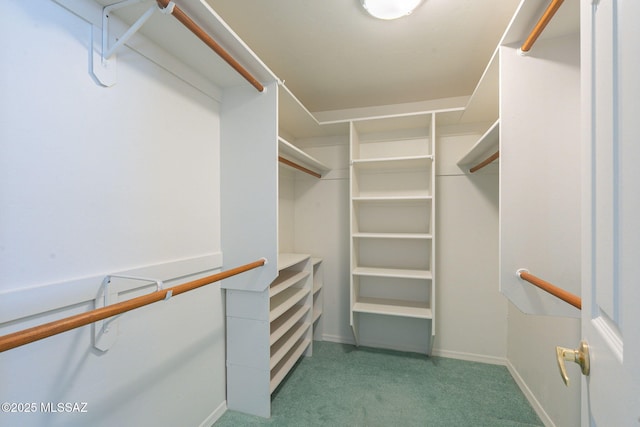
[206,0,524,112]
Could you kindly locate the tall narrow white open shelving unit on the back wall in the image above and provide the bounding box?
[350,113,435,354]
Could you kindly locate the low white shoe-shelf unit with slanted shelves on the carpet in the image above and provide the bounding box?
[227,253,322,417]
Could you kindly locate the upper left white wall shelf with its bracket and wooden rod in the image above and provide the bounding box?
[89,0,268,92]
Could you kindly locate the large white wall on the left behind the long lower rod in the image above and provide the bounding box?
[0,0,225,426]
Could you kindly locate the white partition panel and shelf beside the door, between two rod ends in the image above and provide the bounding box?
[499,0,584,318]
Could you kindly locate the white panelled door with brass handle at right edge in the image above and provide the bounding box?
[581,0,640,427]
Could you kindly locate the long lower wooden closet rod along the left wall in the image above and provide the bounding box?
[0,259,266,352]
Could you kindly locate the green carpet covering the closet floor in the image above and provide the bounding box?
[215,341,543,427]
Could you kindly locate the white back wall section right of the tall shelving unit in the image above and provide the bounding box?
[434,127,507,363]
